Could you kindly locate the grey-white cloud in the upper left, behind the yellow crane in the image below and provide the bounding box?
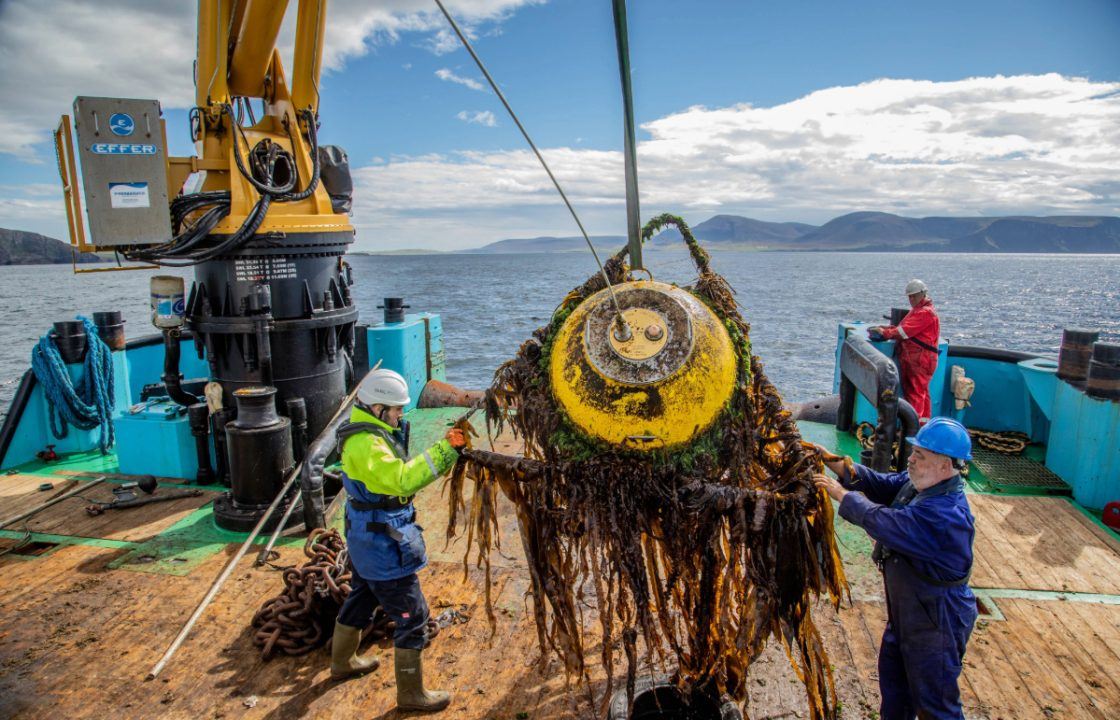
[0,0,543,161]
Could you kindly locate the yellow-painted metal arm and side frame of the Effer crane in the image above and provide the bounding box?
[55,0,354,272]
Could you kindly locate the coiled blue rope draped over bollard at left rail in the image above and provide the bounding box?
[31,316,115,455]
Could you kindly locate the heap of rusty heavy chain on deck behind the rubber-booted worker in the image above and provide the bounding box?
[252,527,440,660]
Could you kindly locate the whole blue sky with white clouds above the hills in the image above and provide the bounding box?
[0,0,1120,250]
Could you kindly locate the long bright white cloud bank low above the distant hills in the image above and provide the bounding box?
[354,74,1120,247]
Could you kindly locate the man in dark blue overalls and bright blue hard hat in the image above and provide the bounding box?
[814,418,977,720]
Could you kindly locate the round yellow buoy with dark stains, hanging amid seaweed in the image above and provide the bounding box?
[549,280,736,450]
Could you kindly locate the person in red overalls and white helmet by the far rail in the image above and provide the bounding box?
[868,280,941,422]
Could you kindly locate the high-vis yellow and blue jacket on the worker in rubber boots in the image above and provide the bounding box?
[342,408,459,580]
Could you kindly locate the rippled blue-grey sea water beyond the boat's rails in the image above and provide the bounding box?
[0,249,1120,413]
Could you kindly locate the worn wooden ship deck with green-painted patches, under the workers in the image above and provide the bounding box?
[0,411,1120,720]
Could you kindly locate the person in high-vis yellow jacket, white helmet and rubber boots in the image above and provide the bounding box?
[330,370,466,711]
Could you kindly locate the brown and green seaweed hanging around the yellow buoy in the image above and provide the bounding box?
[448,215,847,718]
